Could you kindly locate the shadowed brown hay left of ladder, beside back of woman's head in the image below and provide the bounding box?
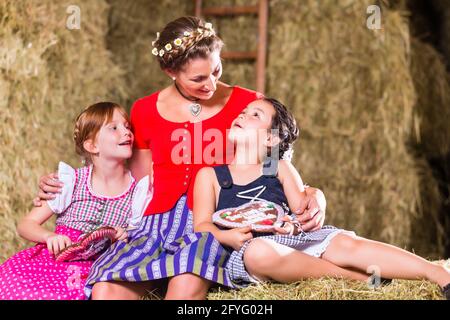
[106,0,194,106]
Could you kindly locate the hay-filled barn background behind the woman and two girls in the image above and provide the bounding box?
[0,0,450,297]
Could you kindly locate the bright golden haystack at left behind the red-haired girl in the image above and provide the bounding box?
[0,0,125,261]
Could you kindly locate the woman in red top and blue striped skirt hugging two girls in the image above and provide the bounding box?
[36,17,325,299]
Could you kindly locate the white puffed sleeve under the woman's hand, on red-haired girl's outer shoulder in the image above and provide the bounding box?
[47,161,76,214]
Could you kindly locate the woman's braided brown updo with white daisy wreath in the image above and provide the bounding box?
[152,16,223,72]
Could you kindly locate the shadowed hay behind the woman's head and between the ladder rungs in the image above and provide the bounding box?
[107,0,257,96]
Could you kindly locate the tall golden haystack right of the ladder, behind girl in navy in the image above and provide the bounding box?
[268,0,444,256]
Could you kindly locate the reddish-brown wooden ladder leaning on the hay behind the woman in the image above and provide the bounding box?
[195,0,269,93]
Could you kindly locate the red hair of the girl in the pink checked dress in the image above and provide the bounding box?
[73,102,130,164]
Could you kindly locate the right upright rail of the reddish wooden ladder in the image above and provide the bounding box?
[256,0,269,93]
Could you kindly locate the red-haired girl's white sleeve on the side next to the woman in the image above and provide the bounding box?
[128,176,153,229]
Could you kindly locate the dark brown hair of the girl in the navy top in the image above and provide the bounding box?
[263,97,300,161]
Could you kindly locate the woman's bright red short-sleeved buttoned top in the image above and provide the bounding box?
[131,86,262,216]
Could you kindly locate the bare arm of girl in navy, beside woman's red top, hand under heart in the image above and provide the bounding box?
[193,167,253,250]
